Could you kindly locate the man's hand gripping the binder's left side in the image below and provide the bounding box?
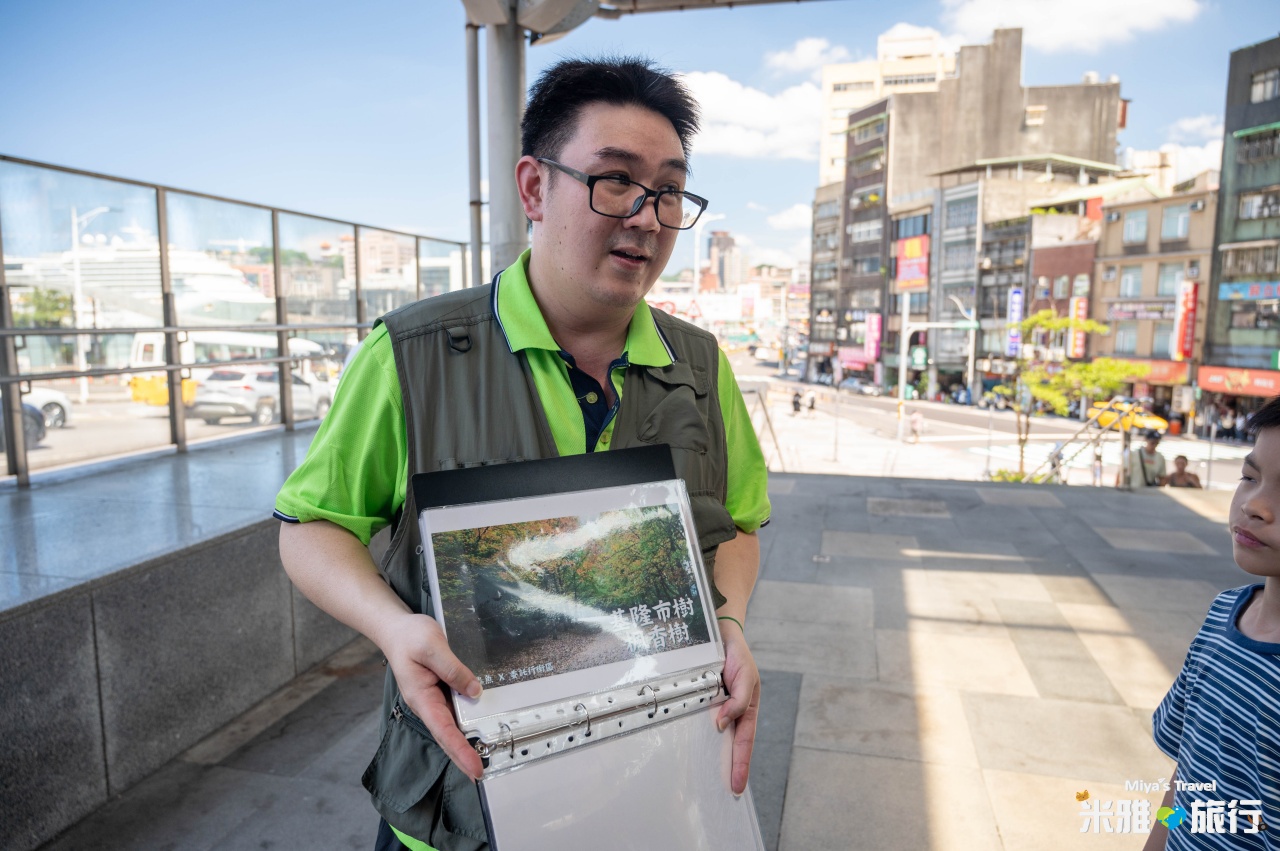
[384,612,484,779]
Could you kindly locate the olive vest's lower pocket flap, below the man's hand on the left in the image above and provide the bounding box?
[361,699,449,813]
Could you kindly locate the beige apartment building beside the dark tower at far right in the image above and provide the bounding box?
[1089,171,1217,413]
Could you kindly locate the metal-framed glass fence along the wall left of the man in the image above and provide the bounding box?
[0,156,468,486]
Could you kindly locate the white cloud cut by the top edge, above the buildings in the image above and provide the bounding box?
[942,0,1206,54]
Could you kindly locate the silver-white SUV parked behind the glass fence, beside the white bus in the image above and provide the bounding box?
[188,366,330,425]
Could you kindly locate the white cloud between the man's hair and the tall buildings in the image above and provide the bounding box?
[684,72,822,160]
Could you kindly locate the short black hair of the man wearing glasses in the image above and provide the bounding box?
[520,56,698,160]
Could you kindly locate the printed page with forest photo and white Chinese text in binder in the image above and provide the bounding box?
[420,480,723,724]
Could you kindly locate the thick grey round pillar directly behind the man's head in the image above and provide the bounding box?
[488,17,529,272]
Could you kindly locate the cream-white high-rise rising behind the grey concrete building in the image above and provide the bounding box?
[818,28,956,186]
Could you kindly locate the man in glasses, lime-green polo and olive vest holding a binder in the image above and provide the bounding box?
[276,59,769,851]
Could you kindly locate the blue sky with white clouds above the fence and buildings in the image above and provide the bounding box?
[0,0,1280,273]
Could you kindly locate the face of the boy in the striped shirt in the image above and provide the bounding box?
[1229,429,1280,576]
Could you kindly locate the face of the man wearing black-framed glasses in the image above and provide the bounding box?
[530,104,687,308]
